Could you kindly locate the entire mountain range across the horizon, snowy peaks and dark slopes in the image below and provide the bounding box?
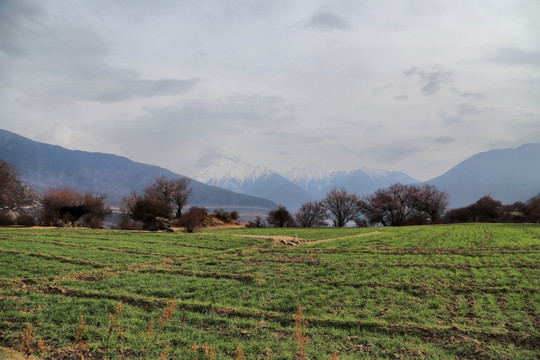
[0,130,540,214]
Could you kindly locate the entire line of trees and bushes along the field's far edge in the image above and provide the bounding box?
[0,159,540,232]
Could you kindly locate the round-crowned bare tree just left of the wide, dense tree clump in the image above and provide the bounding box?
[322,188,360,227]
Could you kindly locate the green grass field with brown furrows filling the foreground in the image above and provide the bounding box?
[0,224,540,359]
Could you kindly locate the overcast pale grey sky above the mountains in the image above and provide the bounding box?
[0,0,540,180]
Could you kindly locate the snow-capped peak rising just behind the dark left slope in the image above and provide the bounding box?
[188,155,311,211]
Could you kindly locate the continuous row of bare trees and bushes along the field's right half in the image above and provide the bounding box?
[264,183,540,227]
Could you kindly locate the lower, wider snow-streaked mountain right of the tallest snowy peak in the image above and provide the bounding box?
[286,167,418,199]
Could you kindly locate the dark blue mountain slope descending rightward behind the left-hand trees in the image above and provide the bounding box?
[0,130,277,213]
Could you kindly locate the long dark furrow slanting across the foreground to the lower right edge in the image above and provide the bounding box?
[29,285,540,349]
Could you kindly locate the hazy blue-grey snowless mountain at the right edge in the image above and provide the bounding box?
[426,144,540,208]
